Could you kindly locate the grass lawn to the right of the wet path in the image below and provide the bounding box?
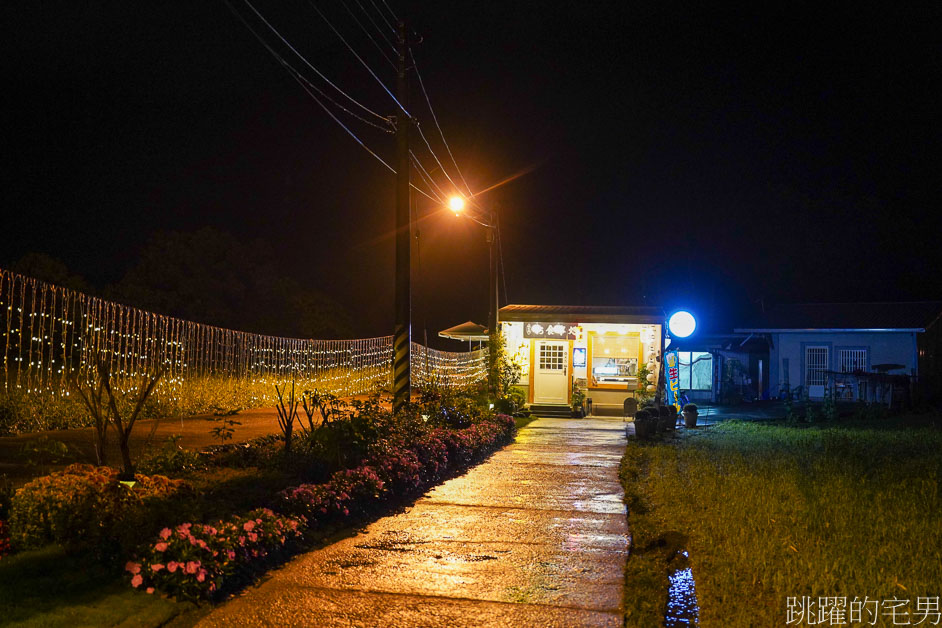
[621,415,942,626]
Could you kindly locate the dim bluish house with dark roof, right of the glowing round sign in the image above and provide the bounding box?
[735,301,942,399]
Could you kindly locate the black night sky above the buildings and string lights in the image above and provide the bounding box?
[0,0,942,344]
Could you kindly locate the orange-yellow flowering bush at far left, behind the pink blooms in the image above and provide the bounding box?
[9,464,194,558]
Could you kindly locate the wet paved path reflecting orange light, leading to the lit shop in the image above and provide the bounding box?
[200,419,628,627]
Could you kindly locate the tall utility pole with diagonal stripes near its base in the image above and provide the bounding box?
[393,20,412,412]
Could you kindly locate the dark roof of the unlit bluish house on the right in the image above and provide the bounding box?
[736,301,942,332]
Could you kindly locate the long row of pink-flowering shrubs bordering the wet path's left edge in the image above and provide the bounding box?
[126,415,516,600]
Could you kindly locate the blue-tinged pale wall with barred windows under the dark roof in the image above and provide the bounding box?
[769,331,916,398]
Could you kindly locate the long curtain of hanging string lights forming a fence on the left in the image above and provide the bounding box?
[0,269,486,399]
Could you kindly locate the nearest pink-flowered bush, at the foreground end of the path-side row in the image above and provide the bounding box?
[124,508,304,601]
